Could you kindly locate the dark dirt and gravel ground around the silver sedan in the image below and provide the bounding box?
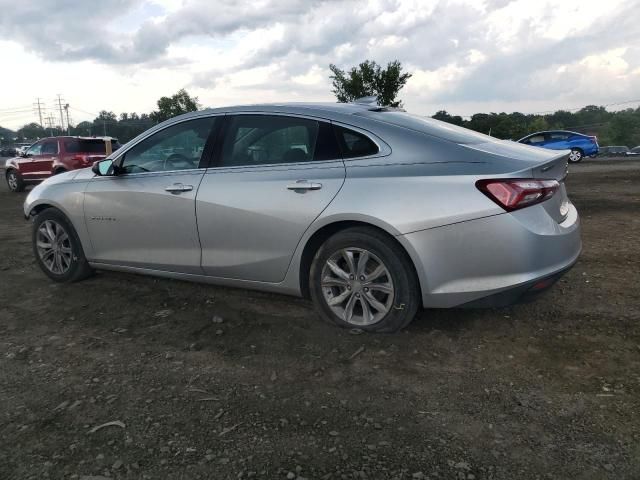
[0,162,640,480]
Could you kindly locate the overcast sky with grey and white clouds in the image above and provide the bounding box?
[0,0,640,128]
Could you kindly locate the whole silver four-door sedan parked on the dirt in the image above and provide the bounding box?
[24,104,581,332]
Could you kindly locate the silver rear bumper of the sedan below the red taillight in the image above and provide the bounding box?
[398,205,582,308]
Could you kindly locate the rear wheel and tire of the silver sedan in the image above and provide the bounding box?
[309,227,421,333]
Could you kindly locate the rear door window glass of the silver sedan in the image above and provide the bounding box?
[221,115,324,166]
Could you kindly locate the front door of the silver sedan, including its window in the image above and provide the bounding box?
[84,116,219,274]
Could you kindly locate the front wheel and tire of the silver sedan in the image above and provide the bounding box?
[31,208,93,283]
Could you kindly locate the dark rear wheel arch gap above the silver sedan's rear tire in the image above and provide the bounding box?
[298,219,424,304]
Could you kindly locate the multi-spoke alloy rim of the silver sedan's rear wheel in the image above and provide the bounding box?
[321,248,394,326]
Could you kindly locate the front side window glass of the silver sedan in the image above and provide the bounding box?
[120,117,216,173]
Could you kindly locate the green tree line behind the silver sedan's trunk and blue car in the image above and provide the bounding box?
[433,105,640,148]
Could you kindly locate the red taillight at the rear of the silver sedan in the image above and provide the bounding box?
[476,178,560,212]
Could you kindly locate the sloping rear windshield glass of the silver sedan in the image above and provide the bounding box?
[356,111,496,144]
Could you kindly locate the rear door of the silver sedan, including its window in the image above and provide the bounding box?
[196,114,345,282]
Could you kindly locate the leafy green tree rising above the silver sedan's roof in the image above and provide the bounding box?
[329,60,411,107]
